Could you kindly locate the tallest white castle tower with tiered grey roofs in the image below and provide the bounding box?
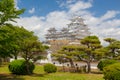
[68,17,90,40]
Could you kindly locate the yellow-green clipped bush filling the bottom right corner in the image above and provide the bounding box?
[103,63,120,80]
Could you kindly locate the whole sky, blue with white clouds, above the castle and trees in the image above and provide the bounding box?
[15,0,120,41]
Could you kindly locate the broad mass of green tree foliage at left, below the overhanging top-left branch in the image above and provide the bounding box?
[0,25,46,61]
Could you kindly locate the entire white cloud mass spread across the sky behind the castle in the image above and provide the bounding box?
[14,0,120,43]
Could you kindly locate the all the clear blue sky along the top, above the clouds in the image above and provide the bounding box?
[18,0,120,16]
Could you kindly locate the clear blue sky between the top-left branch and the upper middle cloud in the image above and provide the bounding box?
[18,0,60,16]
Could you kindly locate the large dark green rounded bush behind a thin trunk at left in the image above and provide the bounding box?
[8,60,35,75]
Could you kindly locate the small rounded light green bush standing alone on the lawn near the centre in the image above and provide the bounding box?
[44,63,57,73]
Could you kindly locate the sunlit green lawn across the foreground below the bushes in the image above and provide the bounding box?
[0,66,104,80]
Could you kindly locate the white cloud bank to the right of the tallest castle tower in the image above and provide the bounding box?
[86,11,120,42]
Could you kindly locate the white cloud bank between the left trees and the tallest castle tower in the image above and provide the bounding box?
[16,11,69,40]
